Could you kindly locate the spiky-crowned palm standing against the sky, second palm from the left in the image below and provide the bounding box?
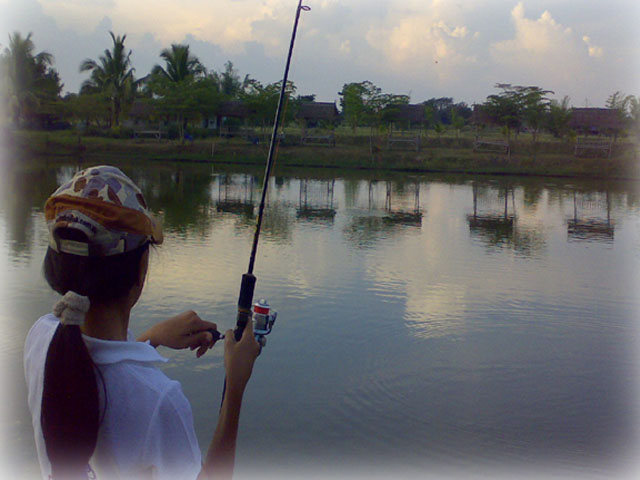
[80,32,135,126]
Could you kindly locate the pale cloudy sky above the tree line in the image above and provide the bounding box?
[0,0,640,107]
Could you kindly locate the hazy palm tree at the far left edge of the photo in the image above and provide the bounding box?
[0,32,54,123]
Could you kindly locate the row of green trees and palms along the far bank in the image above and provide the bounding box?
[0,32,640,142]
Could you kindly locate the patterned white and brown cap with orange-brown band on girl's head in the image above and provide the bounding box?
[45,165,163,257]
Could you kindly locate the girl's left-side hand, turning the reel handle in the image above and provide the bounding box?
[138,310,217,358]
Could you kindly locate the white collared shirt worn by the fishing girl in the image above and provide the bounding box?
[24,314,201,480]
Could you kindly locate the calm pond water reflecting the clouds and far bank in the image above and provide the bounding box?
[0,160,640,478]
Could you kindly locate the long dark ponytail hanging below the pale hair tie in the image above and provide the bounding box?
[40,323,100,480]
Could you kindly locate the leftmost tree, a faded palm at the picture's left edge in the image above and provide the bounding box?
[0,32,62,124]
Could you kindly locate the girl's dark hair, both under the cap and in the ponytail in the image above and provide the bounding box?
[40,229,149,480]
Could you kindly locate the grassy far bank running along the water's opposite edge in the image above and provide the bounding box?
[4,127,640,179]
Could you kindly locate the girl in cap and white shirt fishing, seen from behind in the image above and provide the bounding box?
[24,166,259,480]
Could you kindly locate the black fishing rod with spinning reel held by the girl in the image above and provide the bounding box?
[234,0,311,345]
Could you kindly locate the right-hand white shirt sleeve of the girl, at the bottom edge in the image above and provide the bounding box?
[142,385,202,480]
